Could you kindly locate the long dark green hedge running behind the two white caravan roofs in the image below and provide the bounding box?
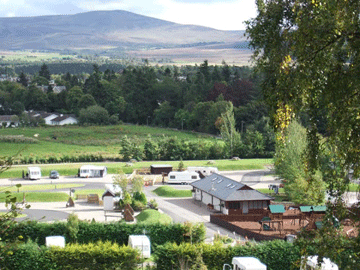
[3,221,205,251]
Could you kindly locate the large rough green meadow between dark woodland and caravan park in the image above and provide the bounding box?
[0,125,216,163]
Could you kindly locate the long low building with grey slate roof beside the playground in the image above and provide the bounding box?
[190,173,274,215]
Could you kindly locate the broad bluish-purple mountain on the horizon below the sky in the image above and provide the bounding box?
[0,10,245,50]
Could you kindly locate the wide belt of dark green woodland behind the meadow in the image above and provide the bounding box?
[0,61,274,157]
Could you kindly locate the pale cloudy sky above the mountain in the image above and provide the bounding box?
[0,0,256,30]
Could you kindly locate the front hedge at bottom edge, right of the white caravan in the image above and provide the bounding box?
[155,240,301,270]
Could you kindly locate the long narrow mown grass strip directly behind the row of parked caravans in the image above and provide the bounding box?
[0,159,273,178]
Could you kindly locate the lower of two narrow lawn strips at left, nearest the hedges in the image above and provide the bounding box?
[0,192,69,202]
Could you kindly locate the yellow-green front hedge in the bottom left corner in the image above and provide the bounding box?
[0,241,143,270]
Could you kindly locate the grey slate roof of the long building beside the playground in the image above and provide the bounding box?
[190,173,273,201]
